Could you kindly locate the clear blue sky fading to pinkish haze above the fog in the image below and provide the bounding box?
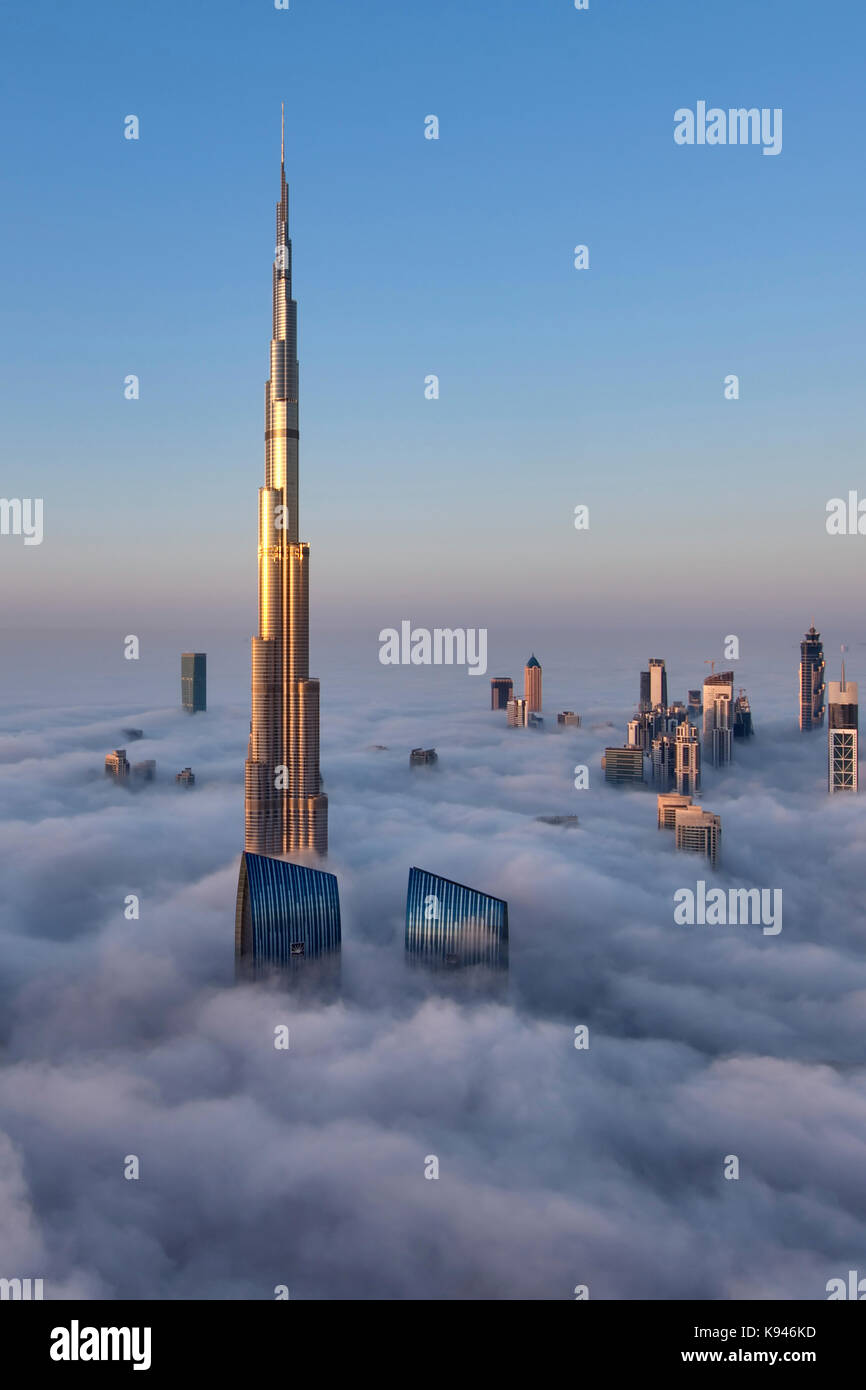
[0,0,866,639]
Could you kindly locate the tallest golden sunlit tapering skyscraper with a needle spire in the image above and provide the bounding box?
[245,116,328,855]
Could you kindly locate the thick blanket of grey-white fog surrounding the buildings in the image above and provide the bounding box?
[0,642,866,1300]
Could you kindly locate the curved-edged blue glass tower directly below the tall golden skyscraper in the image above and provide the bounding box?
[235,851,342,974]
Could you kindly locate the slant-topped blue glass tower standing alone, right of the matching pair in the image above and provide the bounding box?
[406,867,509,970]
